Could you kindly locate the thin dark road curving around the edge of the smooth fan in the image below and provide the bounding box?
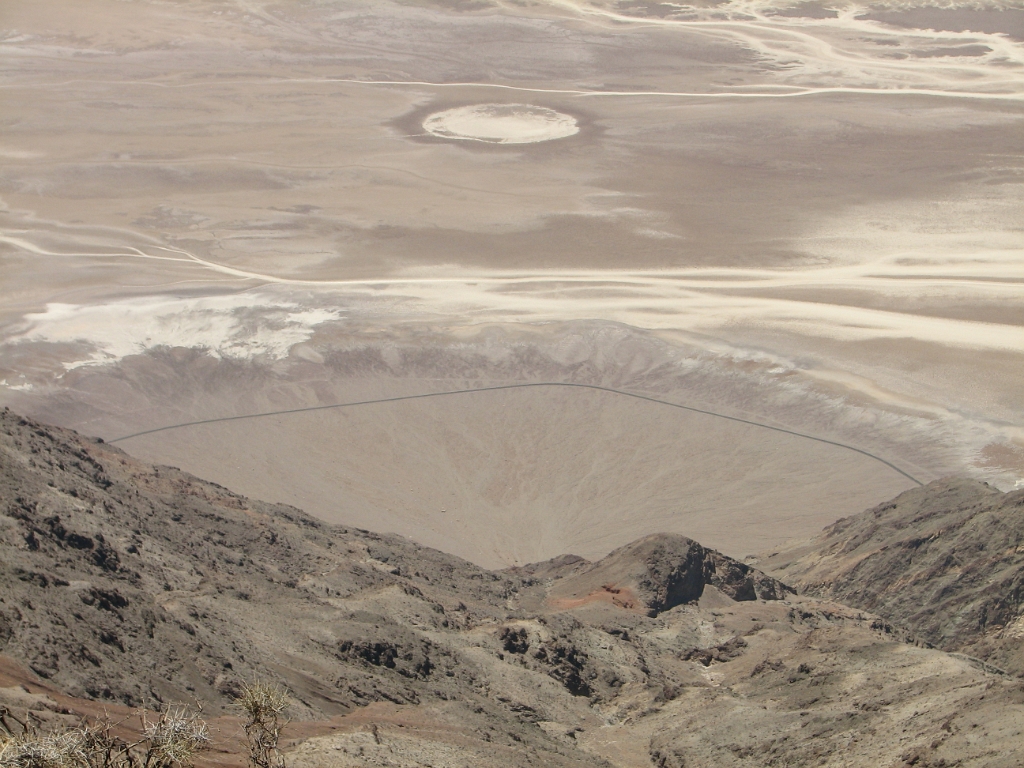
[108,382,925,485]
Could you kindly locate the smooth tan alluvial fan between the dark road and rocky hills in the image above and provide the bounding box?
[119,389,912,567]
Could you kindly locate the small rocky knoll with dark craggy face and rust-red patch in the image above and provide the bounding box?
[544,534,794,617]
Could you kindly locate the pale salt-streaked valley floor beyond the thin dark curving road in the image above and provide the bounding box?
[0,0,1024,564]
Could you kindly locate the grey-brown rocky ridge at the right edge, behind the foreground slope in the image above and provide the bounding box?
[762,478,1024,675]
